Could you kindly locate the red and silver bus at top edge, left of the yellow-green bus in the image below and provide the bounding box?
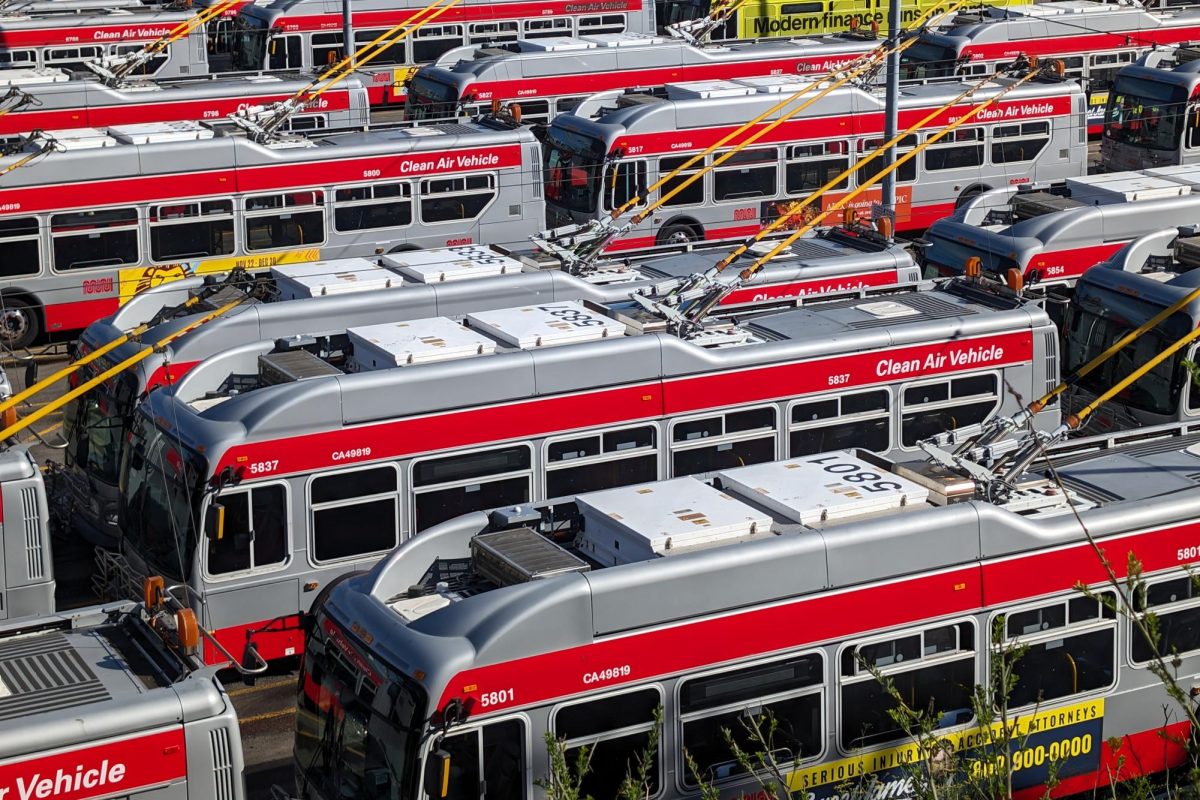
[230,0,654,106]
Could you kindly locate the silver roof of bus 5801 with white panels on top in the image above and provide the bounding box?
[325,428,1200,712]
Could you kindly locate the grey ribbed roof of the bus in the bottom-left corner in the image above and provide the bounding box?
[0,603,226,759]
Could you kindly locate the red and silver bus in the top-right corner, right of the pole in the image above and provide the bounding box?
[901,0,1200,133]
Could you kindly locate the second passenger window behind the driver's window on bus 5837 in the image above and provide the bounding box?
[412,445,533,534]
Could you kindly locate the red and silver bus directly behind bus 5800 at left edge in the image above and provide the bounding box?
[0,70,371,138]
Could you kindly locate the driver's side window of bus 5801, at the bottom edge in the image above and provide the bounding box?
[426,720,526,800]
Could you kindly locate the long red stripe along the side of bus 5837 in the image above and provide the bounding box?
[212,331,1033,479]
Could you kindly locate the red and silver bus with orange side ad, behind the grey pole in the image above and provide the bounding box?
[545,71,1087,252]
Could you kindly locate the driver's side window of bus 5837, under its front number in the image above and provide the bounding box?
[206,483,289,575]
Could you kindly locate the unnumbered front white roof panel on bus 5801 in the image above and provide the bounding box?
[576,477,770,565]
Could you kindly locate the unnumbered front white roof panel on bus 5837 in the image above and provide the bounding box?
[346,317,496,372]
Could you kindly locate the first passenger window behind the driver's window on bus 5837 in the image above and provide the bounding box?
[308,465,400,563]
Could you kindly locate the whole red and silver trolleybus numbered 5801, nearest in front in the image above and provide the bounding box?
[294,427,1200,800]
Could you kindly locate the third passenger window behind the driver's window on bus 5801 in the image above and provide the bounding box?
[839,622,979,750]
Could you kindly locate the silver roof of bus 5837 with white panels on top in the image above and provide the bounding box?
[140,275,1049,471]
